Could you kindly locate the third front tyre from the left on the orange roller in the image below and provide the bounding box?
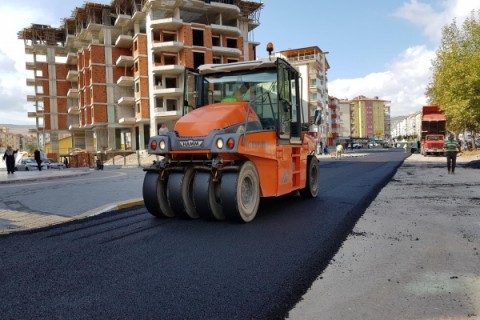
[192,171,225,220]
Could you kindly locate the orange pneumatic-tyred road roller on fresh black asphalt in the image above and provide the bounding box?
[143,57,321,223]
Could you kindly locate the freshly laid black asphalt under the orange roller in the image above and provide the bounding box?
[0,151,406,319]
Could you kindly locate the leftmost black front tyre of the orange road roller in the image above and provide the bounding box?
[142,172,175,218]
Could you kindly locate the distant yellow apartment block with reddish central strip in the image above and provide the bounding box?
[350,96,391,139]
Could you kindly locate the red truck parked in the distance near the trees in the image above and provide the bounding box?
[421,106,446,156]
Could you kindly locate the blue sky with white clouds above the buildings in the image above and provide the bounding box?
[0,0,480,125]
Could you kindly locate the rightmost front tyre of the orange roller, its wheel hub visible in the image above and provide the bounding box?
[220,161,260,223]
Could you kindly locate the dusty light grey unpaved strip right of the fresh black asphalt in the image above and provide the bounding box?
[288,154,480,320]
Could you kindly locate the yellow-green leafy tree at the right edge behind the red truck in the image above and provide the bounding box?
[426,10,480,139]
